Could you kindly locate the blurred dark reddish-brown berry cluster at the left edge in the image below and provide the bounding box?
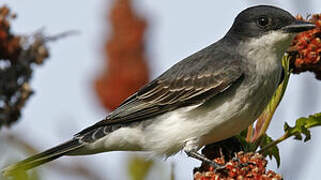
[0,6,49,129]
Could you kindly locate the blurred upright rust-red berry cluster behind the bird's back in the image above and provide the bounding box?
[94,0,149,110]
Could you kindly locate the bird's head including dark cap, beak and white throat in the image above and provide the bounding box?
[227,5,315,52]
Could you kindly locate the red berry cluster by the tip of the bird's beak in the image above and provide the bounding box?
[288,14,321,79]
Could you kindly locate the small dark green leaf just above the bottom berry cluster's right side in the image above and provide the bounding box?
[260,134,281,167]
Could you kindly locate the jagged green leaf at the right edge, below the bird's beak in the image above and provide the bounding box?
[283,113,321,142]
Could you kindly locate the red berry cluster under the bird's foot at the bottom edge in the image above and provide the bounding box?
[194,151,282,180]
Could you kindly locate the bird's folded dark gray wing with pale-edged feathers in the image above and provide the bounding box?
[75,44,243,142]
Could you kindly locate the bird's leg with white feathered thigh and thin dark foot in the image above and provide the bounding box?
[184,139,225,170]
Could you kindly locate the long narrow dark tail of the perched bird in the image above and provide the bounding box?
[2,139,83,176]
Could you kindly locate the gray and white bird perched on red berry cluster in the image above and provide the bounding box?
[2,5,315,176]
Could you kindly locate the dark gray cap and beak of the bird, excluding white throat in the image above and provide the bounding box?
[227,5,315,39]
